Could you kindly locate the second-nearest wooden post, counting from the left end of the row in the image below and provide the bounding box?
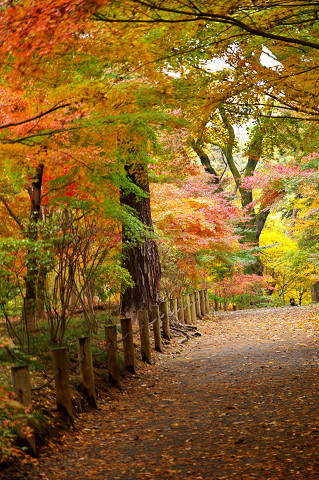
[51,347,73,423]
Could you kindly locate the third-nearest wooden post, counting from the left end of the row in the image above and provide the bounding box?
[78,337,97,408]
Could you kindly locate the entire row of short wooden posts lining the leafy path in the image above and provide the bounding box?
[11,290,209,453]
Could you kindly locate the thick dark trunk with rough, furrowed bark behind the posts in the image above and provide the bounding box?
[121,165,161,315]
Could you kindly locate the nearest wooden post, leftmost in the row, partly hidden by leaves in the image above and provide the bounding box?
[11,365,37,455]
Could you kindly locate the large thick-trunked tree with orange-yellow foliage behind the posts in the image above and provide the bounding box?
[0,5,179,318]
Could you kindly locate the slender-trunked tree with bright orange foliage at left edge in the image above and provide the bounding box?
[1,76,125,338]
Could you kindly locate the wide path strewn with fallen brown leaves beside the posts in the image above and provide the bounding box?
[0,305,319,480]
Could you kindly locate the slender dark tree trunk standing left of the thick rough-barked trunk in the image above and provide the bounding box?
[23,164,44,332]
